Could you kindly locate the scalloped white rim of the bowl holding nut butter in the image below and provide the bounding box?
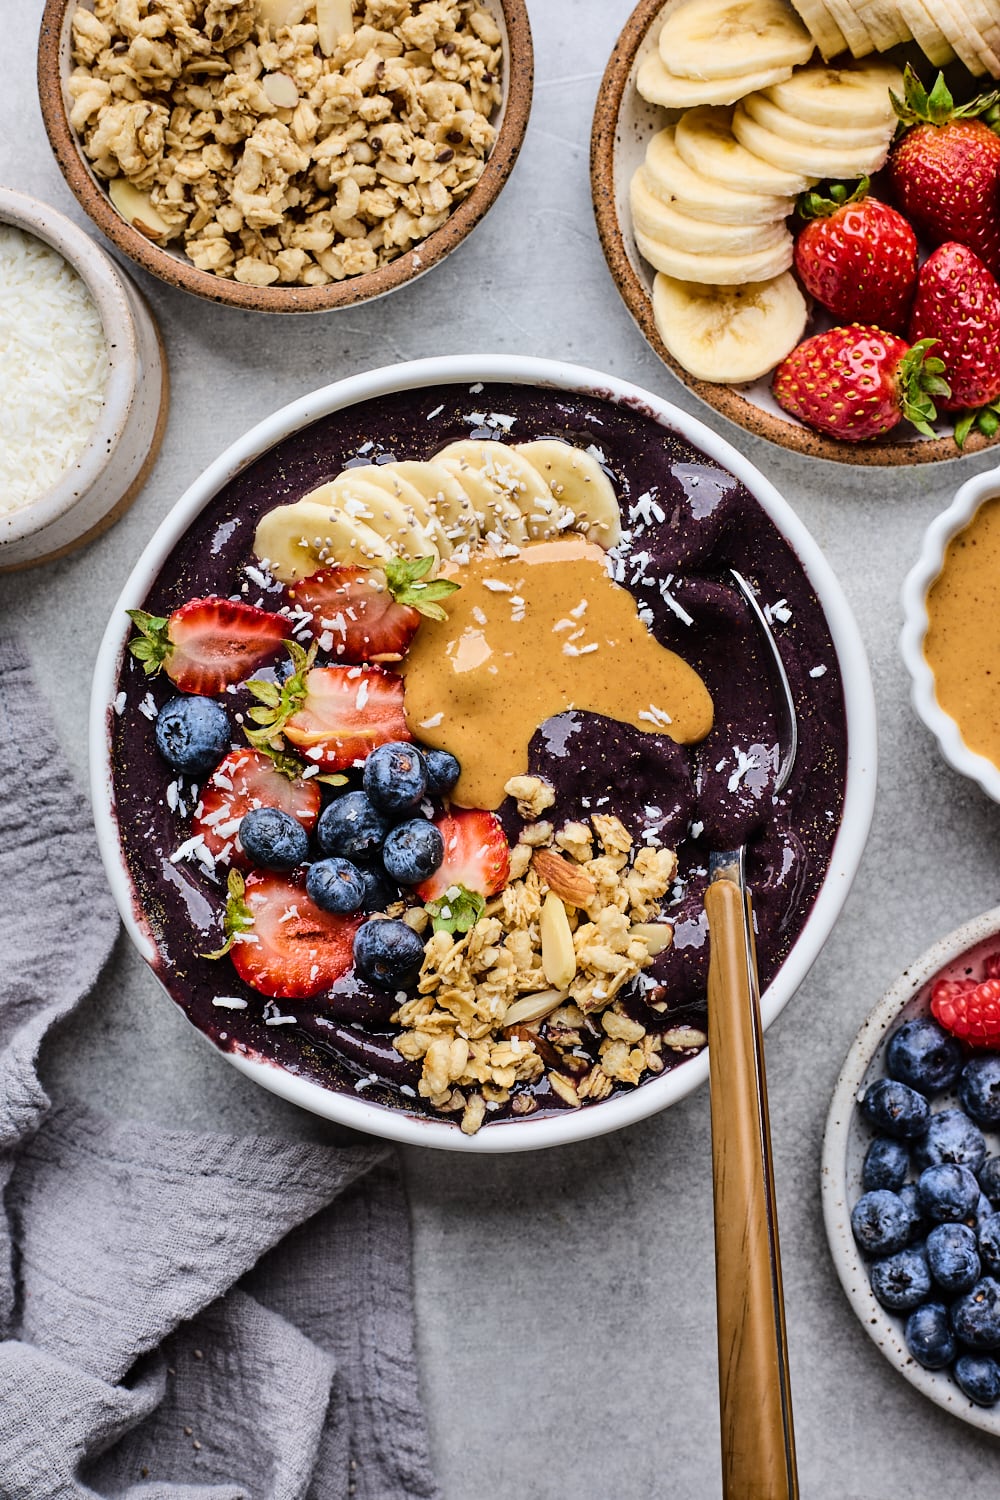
[900,468,1000,803]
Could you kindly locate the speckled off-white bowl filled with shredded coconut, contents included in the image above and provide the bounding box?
[0,188,166,572]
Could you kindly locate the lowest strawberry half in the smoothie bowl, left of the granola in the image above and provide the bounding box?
[226,870,364,1001]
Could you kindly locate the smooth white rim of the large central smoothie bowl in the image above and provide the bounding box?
[88,354,877,1154]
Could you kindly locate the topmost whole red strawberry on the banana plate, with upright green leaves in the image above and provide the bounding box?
[889,66,1000,273]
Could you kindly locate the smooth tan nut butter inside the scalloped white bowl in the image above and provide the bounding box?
[929,497,1000,765]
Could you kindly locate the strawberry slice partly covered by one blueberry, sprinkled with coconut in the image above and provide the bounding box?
[190,747,321,867]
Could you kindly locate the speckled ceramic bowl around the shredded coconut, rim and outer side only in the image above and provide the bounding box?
[0,188,168,572]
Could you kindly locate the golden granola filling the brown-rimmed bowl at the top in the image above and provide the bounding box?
[69,0,501,287]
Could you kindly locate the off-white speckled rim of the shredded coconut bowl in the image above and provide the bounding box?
[0,186,138,543]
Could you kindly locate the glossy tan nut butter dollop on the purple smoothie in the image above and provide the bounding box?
[400,537,712,809]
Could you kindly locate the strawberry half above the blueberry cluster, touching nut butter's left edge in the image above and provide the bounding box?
[282,665,411,771]
